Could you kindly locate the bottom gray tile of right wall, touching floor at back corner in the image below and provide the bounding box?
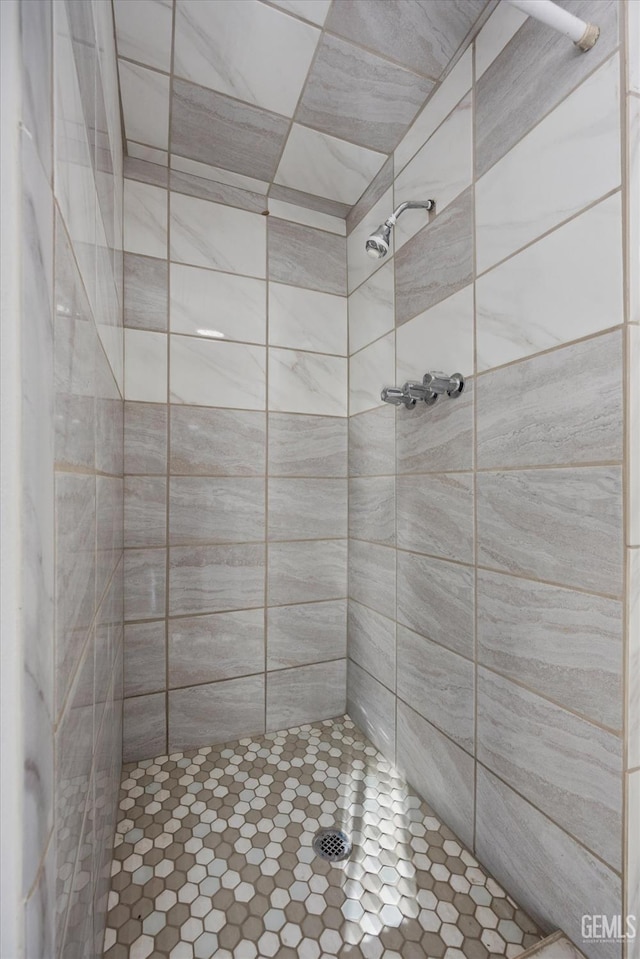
[347,660,396,762]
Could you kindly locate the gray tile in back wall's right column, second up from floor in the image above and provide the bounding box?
[267,599,347,669]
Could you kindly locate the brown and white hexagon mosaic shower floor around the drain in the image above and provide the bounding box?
[104,716,542,959]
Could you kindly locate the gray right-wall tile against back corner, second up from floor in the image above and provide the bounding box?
[347,600,396,689]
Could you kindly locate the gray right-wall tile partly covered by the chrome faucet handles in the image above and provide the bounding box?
[396,378,474,473]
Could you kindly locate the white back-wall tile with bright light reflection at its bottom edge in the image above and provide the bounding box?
[170,263,267,343]
